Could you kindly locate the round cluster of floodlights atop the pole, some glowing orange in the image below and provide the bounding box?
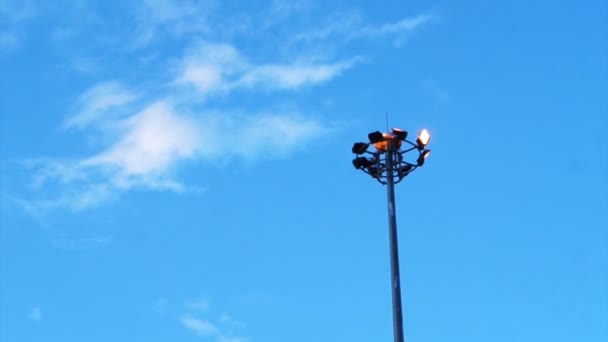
[352,128,431,184]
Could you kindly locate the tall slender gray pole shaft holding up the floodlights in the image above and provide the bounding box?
[386,141,404,342]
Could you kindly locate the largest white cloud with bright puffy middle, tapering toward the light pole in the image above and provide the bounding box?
[20,95,332,211]
